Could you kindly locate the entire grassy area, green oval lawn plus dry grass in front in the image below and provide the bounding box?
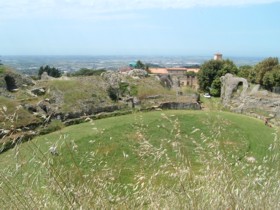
[0,111,280,209]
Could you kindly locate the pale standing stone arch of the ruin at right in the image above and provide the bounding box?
[221,74,249,105]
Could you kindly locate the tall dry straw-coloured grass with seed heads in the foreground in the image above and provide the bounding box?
[0,110,280,209]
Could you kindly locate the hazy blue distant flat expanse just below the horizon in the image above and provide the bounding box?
[0,56,264,74]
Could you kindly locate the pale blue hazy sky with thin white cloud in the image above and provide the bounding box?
[0,0,280,57]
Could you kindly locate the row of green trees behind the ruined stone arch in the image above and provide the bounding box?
[198,58,280,96]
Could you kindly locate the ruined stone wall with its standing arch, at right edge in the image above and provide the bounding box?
[221,74,280,124]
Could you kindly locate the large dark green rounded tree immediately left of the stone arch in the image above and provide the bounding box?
[198,60,238,96]
